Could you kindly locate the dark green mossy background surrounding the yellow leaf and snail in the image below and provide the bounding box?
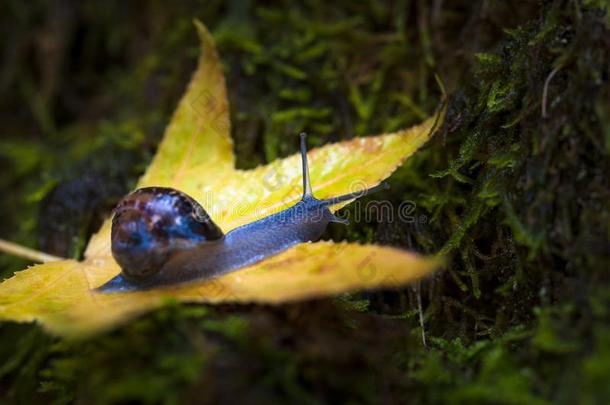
[0,0,610,403]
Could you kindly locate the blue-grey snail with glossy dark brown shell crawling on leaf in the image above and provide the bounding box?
[97,133,387,293]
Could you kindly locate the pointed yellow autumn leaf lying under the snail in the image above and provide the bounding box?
[0,23,444,336]
